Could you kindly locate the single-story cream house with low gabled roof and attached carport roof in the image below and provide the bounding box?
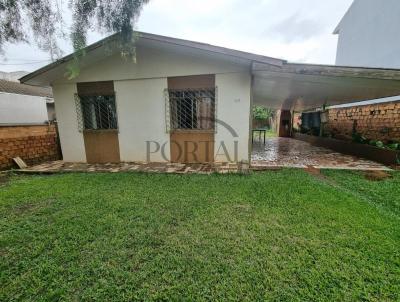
[20,32,400,163]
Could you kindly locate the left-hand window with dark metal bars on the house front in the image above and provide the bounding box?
[75,94,118,131]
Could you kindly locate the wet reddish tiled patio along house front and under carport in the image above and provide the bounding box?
[13,137,390,174]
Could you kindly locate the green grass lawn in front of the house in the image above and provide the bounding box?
[0,170,400,301]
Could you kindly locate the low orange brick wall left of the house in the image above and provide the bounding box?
[0,125,60,170]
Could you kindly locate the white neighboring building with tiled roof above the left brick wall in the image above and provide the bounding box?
[0,79,55,126]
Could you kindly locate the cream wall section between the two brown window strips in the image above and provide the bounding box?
[114,78,170,162]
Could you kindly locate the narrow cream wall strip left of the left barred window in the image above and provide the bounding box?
[53,84,86,162]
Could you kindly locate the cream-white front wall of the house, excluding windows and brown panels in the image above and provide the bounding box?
[53,45,251,162]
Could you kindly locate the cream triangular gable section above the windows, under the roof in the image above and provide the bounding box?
[55,47,248,83]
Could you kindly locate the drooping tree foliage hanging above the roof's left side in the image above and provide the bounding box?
[0,0,149,75]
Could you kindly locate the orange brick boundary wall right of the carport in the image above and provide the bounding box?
[325,101,400,141]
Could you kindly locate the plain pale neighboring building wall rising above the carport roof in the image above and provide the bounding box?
[336,0,400,68]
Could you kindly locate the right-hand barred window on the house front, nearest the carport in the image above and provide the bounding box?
[166,88,216,131]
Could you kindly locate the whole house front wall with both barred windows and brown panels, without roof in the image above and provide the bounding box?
[21,33,266,163]
